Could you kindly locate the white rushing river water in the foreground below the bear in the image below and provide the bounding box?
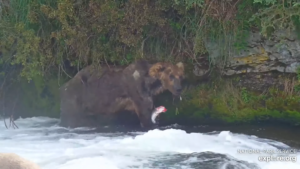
[0,117,300,169]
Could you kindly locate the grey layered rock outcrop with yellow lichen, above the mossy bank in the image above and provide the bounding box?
[194,30,300,76]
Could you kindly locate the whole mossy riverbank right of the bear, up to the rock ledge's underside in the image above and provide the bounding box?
[156,72,300,126]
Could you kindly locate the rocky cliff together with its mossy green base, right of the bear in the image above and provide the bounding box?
[171,30,300,125]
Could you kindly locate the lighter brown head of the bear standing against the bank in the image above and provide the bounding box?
[149,62,184,96]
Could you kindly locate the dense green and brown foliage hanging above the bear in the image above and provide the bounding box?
[0,0,297,80]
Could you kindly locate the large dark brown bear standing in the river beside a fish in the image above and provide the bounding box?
[60,60,184,128]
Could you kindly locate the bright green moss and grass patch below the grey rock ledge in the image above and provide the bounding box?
[164,77,300,125]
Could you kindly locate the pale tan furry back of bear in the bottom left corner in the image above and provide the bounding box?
[0,153,41,169]
